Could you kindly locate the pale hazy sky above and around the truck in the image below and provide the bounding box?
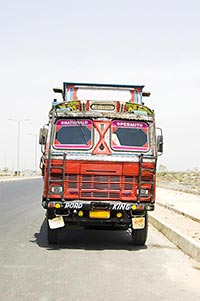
[0,0,200,170]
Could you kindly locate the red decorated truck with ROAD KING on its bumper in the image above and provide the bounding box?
[39,82,163,245]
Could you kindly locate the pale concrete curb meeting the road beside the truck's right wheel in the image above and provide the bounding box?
[149,214,200,262]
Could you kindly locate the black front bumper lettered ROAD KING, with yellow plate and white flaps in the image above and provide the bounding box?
[47,201,152,230]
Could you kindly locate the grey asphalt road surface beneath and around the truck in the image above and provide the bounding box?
[0,179,200,301]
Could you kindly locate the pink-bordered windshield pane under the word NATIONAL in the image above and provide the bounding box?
[54,119,92,149]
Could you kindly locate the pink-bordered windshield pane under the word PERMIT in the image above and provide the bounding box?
[111,120,149,151]
